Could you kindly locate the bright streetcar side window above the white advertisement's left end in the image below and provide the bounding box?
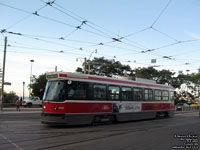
[108,86,120,100]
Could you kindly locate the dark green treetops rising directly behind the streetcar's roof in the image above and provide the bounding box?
[76,57,183,88]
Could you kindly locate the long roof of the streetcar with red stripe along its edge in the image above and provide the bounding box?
[46,72,173,89]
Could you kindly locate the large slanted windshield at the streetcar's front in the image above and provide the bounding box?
[43,81,65,101]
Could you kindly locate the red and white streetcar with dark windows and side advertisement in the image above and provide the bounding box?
[41,72,174,125]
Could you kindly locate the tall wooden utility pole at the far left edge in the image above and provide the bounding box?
[0,37,7,111]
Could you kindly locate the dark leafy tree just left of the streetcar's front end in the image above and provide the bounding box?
[29,73,47,99]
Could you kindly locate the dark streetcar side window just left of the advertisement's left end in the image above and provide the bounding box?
[93,84,106,100]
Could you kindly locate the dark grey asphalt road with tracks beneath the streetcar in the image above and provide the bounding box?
[0,111,200,150]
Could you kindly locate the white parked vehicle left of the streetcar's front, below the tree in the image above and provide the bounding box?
[22,97,42,107]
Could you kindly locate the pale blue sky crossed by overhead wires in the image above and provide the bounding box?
[0,0,200,96]
